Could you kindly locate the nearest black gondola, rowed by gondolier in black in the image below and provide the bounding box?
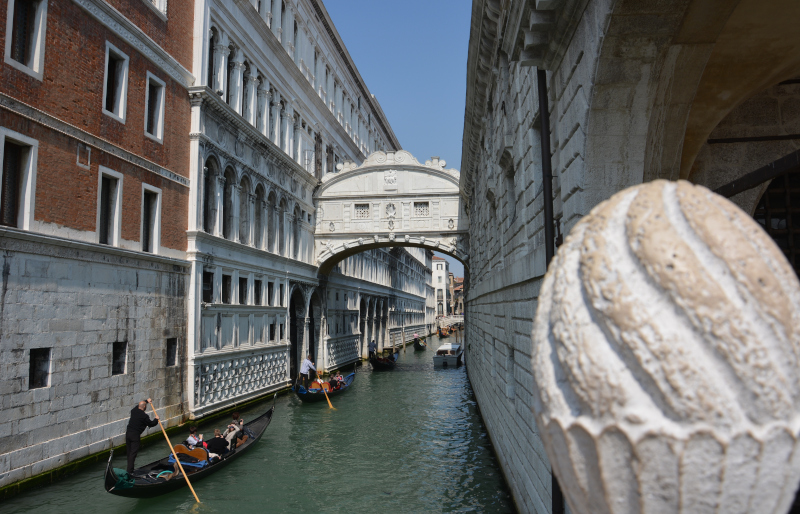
[105,402,275,498]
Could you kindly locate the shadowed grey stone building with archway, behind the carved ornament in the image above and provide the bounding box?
[461,0,800,513]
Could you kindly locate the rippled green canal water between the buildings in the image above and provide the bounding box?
[0,336,514,514]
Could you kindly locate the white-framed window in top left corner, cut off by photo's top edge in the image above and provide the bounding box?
[5,0,47,80]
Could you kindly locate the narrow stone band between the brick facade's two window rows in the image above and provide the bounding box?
[0,93,189,187]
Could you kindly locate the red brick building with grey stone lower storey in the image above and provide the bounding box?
[0,0,194,487]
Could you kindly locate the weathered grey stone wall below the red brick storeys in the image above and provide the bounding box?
[0,229,188,487]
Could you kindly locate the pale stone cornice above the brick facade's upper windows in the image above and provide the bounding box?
[72,0,194,88]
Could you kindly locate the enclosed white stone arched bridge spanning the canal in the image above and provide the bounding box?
[314,150,469,274]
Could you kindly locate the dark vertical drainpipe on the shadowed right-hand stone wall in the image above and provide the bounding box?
[536,69,566,508]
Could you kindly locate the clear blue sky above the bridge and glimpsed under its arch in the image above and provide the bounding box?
[325,0,472,277]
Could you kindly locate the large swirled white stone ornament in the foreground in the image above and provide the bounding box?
[531,180,800,513]
